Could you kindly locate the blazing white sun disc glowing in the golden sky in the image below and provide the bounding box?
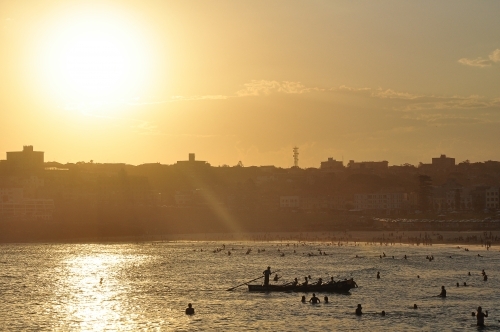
[40,9,149,103]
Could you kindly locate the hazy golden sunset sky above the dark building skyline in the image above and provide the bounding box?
[0,0,500,168]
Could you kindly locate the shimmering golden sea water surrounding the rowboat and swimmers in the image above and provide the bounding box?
[0,242,500,331]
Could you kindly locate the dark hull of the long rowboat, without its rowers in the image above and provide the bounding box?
[248,279,357,293]
